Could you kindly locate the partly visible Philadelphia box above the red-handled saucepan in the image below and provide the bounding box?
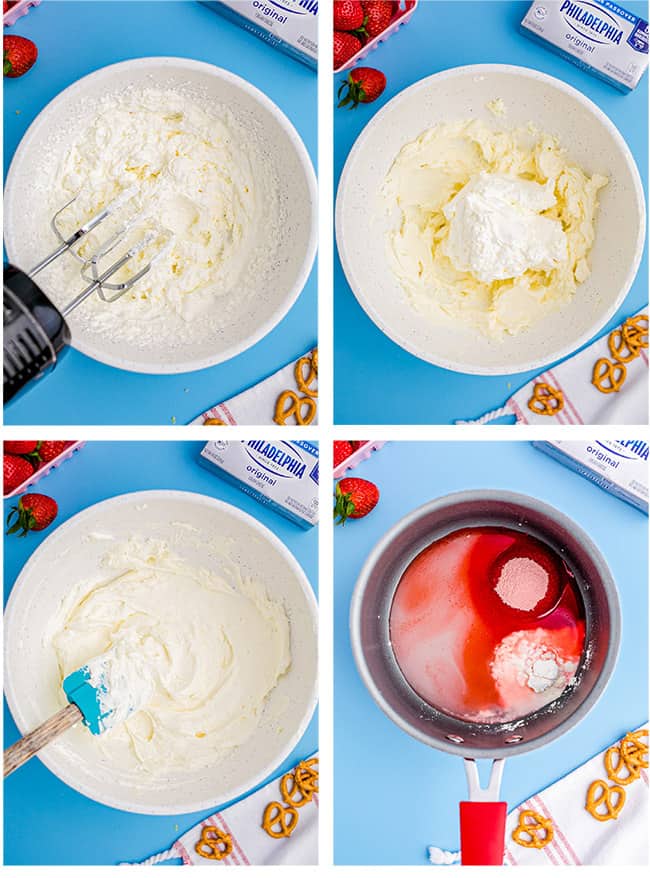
[533,439,648,514]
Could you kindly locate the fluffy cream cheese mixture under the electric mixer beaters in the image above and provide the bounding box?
[40,87,280,349]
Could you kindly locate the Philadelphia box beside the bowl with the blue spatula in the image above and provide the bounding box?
[200,439,318,528]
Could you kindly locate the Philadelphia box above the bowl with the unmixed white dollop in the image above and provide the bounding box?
[521,0,648,92]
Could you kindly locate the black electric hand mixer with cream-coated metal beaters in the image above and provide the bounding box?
[3,190,171,403]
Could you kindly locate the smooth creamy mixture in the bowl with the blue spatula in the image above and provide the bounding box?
[49,537,291,775]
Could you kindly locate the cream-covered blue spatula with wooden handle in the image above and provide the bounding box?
[4,651,148,777]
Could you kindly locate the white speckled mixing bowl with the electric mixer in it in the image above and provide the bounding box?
[4,58,318,374]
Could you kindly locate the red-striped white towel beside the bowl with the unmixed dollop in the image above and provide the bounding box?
[456,310,648,424]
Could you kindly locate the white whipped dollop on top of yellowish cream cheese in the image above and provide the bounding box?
[443,171,567,283]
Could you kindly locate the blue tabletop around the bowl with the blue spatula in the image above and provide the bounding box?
[4,442,318,865]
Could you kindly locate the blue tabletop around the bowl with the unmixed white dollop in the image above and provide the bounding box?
[334,0,648,424]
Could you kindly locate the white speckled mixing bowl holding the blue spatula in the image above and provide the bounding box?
[5,491,317,814]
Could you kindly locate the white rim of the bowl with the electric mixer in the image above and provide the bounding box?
[5,55,318,375]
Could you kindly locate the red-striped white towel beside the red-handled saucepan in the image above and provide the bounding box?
[429,732,648,866]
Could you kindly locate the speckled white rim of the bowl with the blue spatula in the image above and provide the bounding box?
[4,489,318,815]
